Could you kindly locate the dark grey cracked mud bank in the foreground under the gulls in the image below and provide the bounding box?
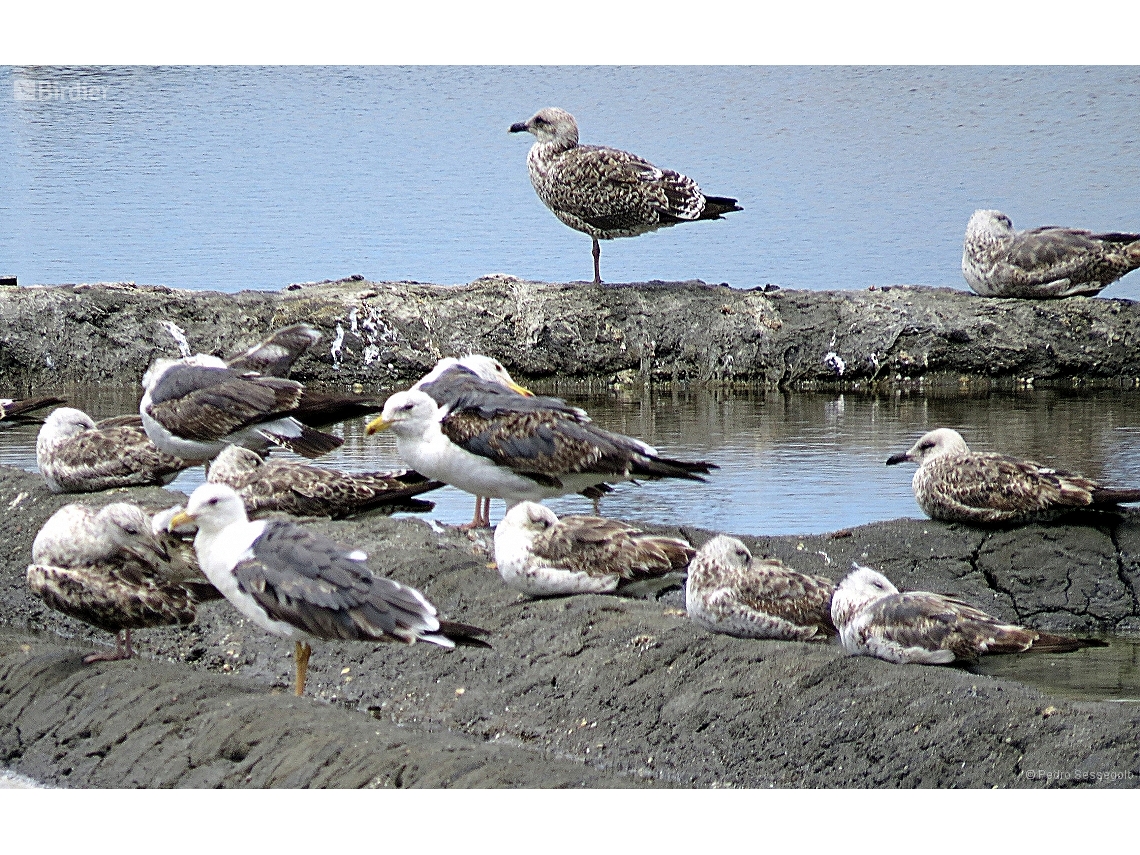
[0,467,1140,787]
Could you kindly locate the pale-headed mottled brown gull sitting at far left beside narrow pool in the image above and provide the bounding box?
[35,407,194,492]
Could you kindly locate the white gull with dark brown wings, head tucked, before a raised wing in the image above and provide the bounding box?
[139,353,344,461]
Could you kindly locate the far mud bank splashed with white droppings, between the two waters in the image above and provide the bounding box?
[0,276,1140,393]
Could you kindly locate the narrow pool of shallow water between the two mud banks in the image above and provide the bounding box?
[0,385,1140,535]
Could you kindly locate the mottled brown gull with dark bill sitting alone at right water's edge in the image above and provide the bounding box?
[887,428,1140,524]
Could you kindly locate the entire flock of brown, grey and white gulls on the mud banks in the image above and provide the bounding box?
[8,108,1140,694]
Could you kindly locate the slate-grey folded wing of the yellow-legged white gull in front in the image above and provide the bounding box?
[234,520,439,642]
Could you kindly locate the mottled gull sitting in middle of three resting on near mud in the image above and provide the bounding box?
[685,535,836,641]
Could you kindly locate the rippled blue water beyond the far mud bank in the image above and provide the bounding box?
[0,66,1140,298]
